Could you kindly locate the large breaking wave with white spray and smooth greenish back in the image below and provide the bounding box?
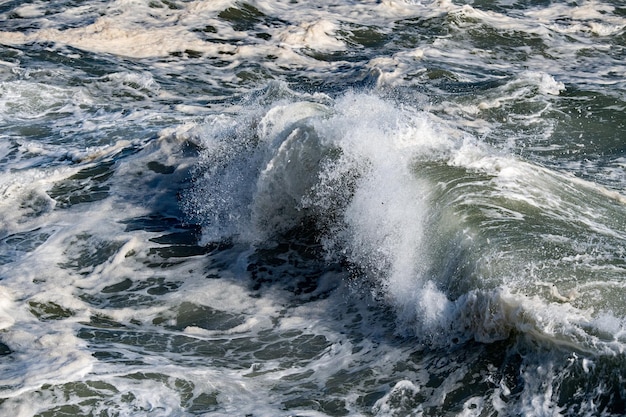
[184,88,621,351]
